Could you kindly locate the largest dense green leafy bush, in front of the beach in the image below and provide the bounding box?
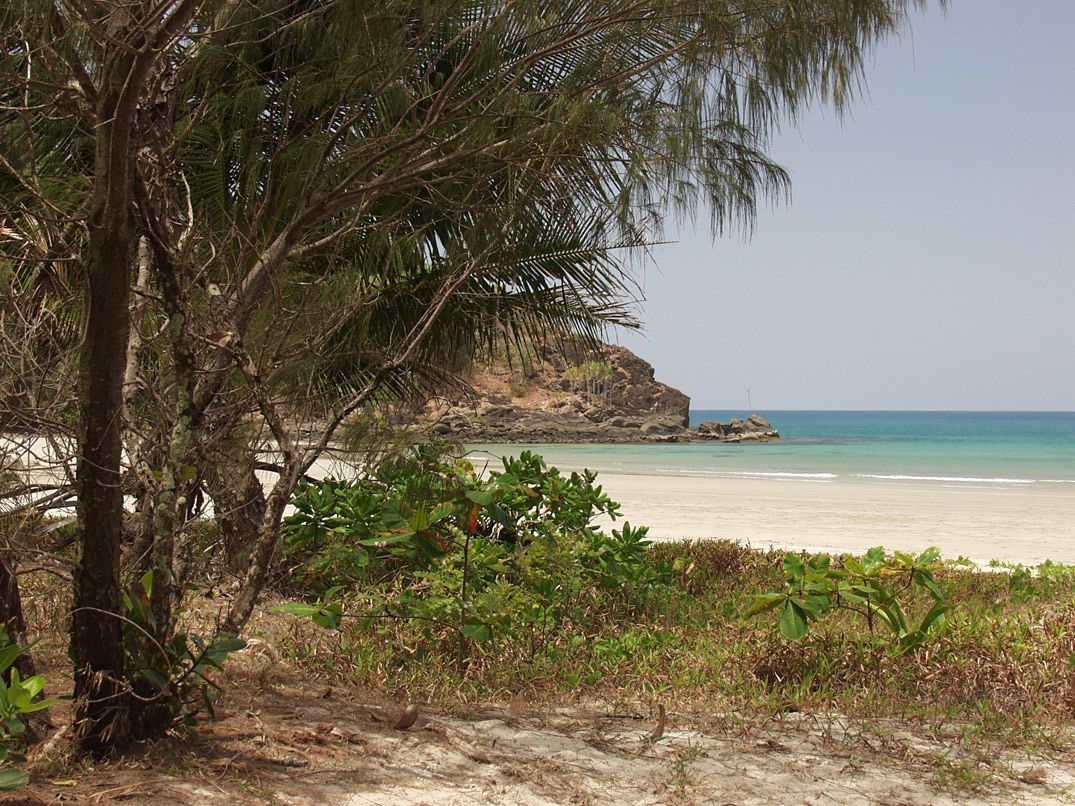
[282,447,675,651]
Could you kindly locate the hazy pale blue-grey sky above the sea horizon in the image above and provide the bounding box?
[618,0,1075,412]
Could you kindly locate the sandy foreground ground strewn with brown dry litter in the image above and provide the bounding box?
[20,657,1075,806]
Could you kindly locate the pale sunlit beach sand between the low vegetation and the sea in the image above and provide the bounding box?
[599,471,1075,565]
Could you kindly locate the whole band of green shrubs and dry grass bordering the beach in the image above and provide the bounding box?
[268,450,1075,746]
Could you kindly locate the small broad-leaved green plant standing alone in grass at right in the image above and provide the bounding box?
[746,547,948,654]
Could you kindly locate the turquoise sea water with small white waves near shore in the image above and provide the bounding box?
[475,411,1075,492]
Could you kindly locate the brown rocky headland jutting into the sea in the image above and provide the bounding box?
[419,345,779,443]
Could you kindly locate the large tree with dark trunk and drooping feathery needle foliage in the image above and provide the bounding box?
[0,0,937,751]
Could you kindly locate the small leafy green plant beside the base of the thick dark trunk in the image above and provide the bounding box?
[124,572,246,725]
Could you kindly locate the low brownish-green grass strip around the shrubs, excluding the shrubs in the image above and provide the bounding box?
[287,542,1075,773]
